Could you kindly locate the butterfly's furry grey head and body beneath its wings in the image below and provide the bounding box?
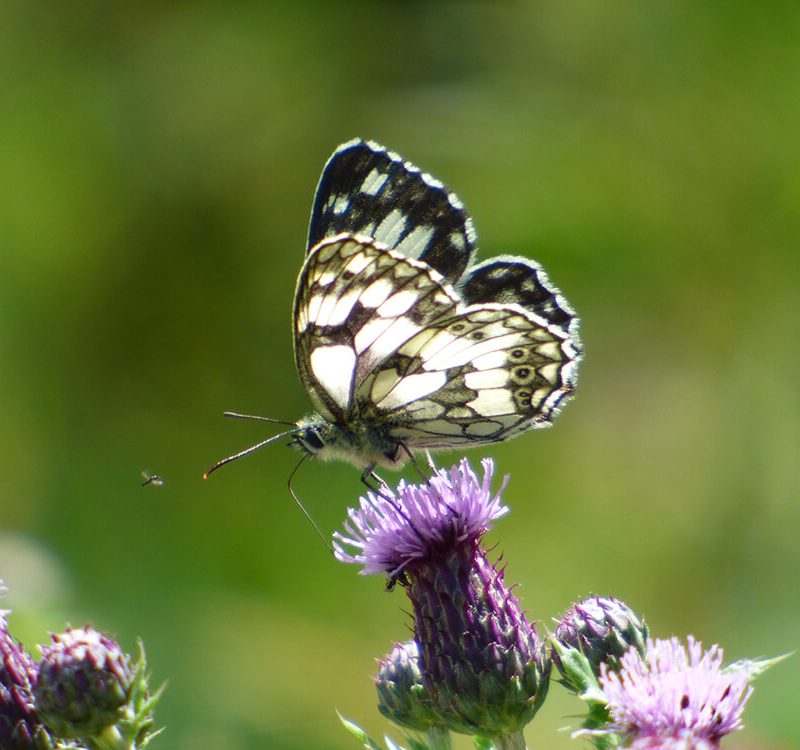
[293,413,408,469]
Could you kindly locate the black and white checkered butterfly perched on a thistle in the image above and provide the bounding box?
[206,139,581,477]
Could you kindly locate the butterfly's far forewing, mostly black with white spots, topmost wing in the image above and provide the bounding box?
[308,140,475,283]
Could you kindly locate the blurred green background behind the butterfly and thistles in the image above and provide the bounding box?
[0,0,800,750]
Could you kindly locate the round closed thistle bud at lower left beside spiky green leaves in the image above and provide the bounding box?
[34,627,133,737]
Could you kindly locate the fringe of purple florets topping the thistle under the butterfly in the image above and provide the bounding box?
[334,459,508,578]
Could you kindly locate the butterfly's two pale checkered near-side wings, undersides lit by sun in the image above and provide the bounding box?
[295,235,577,450]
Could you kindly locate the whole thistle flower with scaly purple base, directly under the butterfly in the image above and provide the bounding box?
[334,459,550,737]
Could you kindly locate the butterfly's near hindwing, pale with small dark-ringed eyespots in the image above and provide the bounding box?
[356,304,580,451]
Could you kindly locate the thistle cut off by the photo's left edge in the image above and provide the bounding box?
[0,610,49,750]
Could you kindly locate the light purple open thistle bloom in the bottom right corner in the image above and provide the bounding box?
[600,636,752,750]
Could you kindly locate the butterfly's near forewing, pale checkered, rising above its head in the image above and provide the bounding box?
[294,234,458,424]
